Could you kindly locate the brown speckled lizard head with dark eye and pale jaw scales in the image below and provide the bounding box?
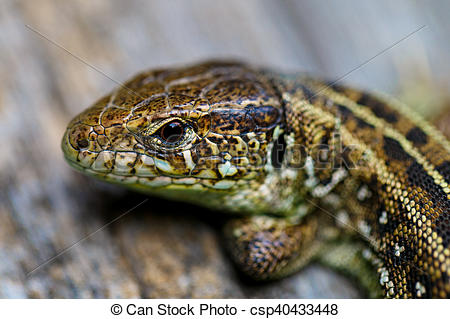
[62,62,282,209]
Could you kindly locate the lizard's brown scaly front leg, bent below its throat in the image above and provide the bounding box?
[224,216,322,280]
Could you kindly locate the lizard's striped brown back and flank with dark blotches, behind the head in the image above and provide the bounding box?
[282,77,450,298]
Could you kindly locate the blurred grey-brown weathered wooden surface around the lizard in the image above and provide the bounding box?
[0,0,450,298]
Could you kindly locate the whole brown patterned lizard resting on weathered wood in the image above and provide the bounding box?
[62,62,450,298]
